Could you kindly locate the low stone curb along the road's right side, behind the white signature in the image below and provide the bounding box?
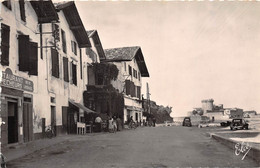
[209,133,260,165]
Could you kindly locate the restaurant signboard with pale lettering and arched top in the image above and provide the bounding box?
[1,68,33,92]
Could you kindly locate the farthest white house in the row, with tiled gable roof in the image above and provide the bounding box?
[101,46,149,122]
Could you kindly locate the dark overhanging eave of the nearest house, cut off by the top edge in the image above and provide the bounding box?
[30,1,59,23]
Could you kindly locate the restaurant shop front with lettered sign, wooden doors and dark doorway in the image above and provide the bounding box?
[0,68,33,146]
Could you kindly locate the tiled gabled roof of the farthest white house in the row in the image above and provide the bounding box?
[105,46,149,77]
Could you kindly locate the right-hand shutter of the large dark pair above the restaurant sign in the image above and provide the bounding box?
[29,42,38,76]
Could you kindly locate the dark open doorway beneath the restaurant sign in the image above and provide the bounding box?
[7,102,18,144]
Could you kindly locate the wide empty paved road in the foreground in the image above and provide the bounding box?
[8,127,259,168]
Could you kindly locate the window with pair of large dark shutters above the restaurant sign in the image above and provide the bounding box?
[18,35,38,75]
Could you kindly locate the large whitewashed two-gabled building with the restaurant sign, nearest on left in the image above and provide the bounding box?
[0,0,99,145]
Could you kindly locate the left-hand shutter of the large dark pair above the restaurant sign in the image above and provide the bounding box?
[18,35,30,72]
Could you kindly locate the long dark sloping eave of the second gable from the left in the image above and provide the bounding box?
[56,1,91,48]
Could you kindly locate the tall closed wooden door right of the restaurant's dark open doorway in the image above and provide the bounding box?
[23,103,33,142]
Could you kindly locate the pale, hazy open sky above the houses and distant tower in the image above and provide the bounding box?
[76,1,260,116]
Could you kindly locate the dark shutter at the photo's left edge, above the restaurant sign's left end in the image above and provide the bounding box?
[1,24,10,66]
